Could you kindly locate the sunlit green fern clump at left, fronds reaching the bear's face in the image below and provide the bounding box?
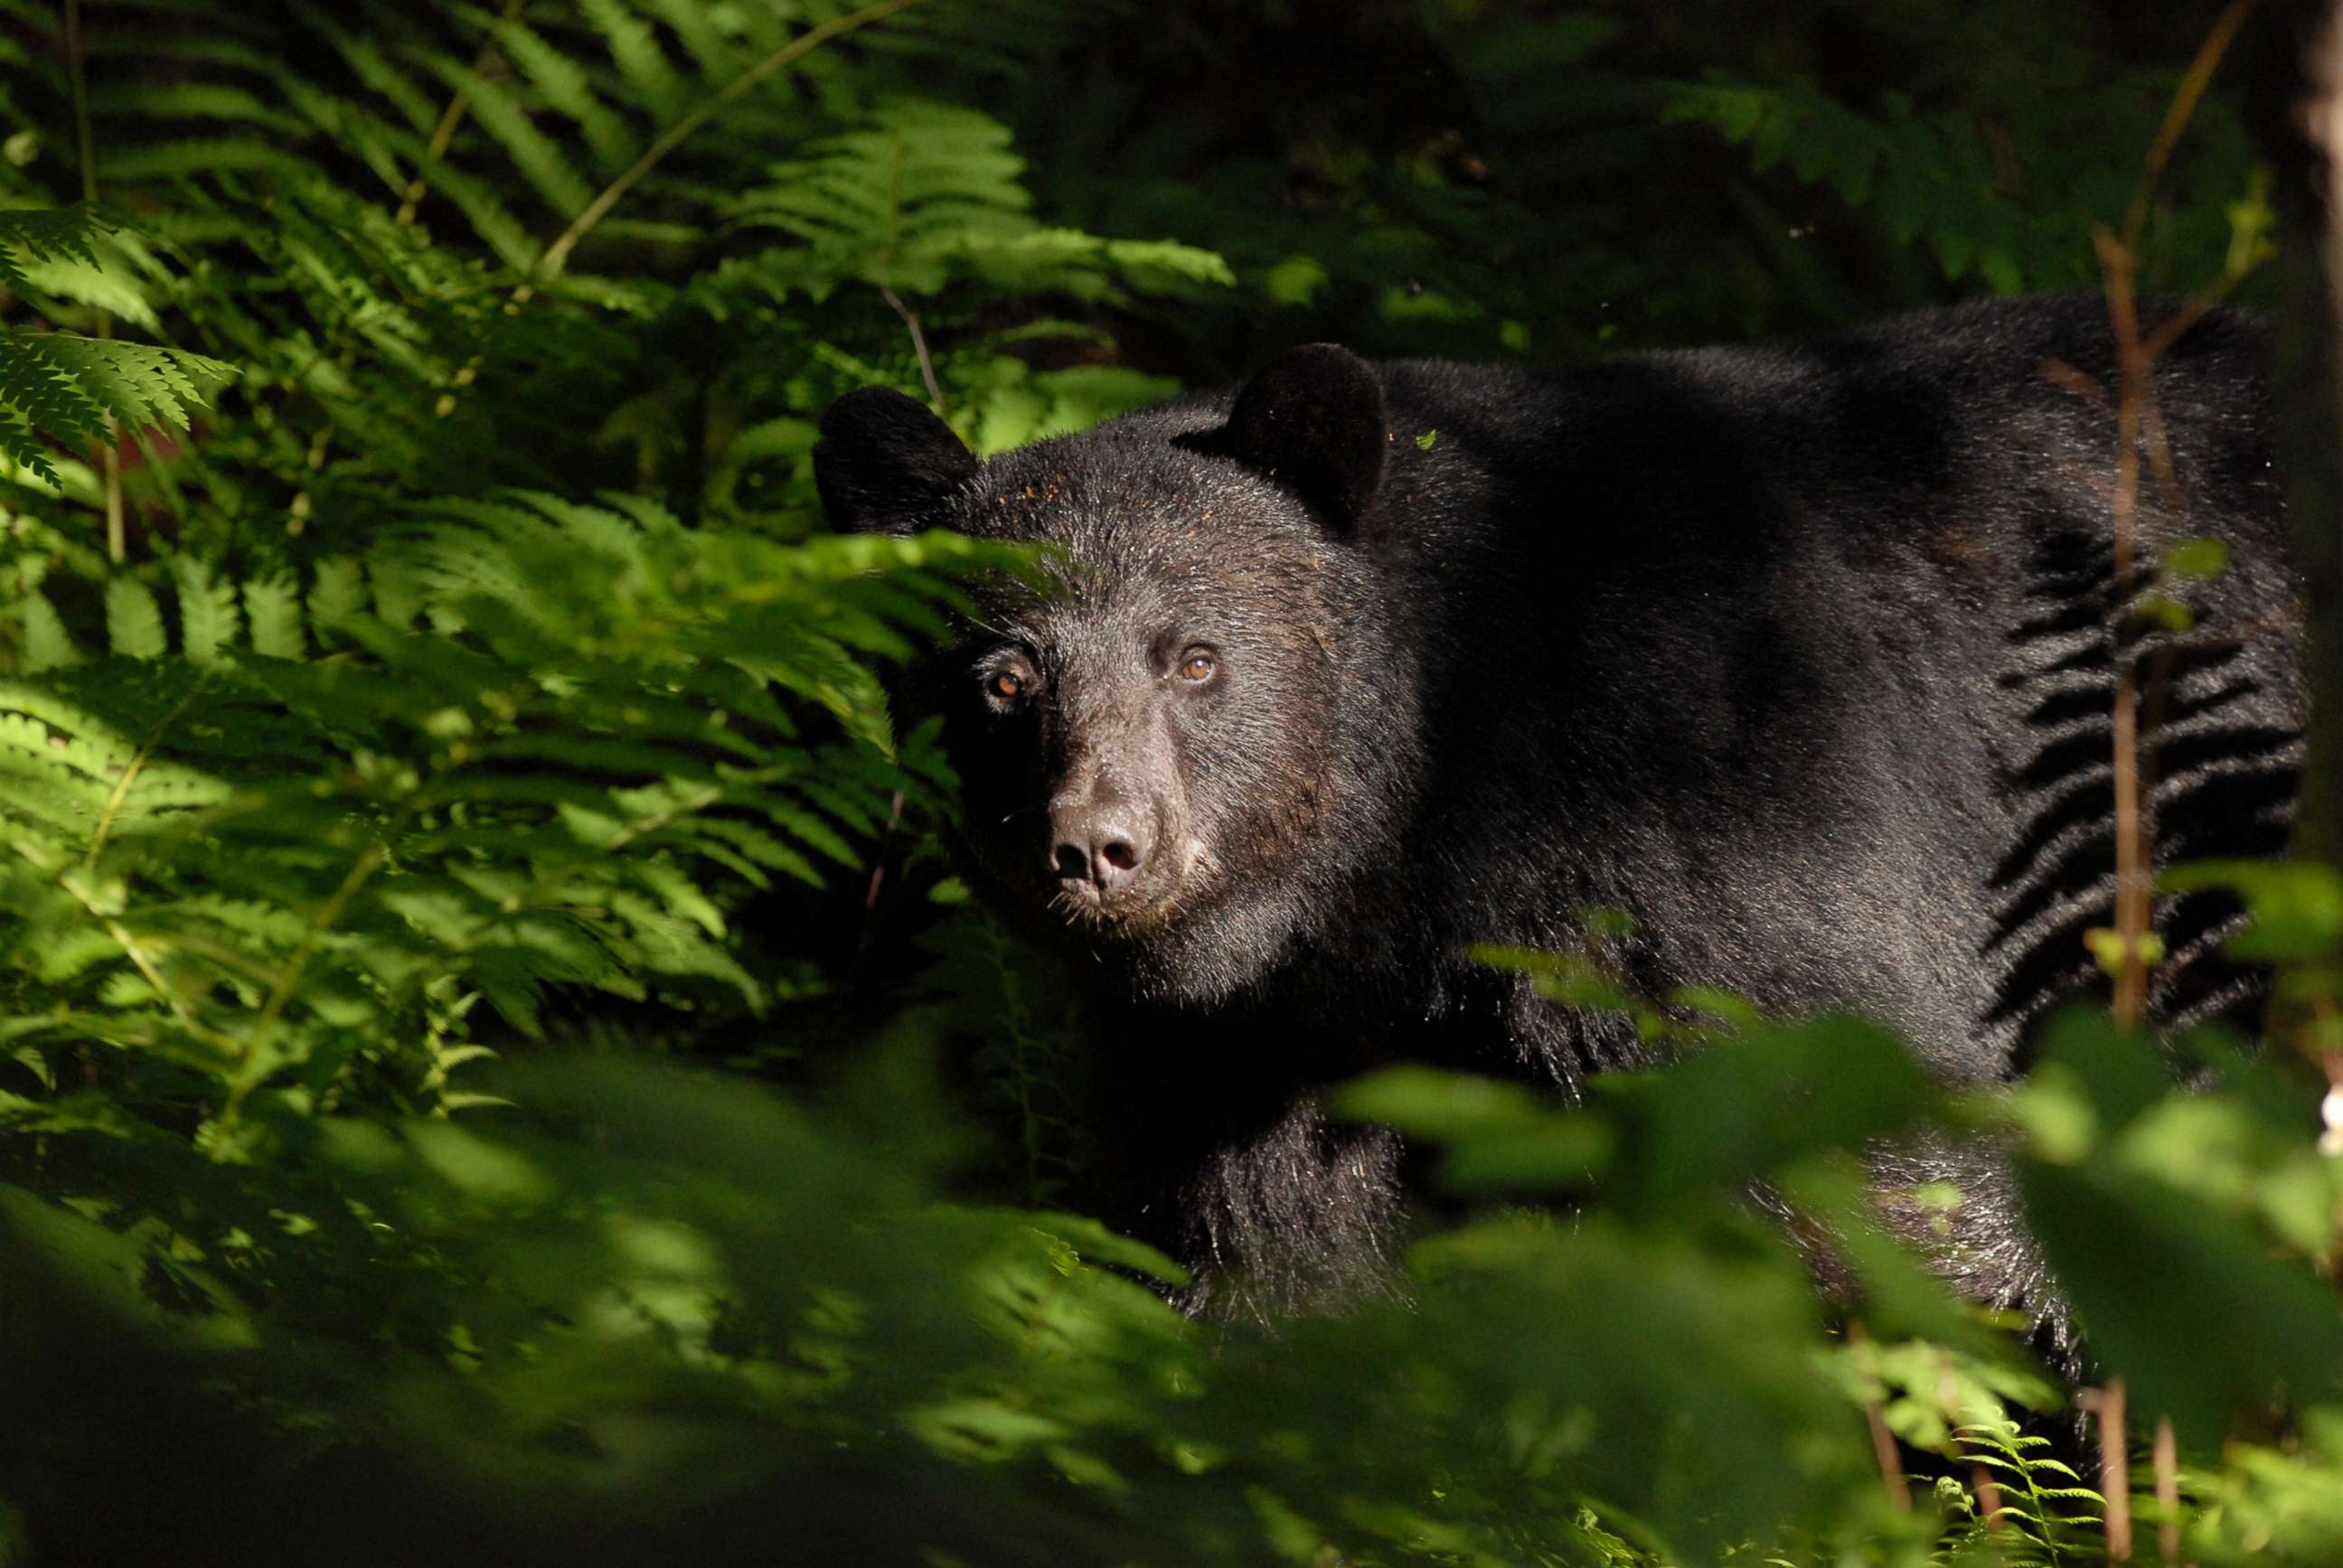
[0,494,1012,1158]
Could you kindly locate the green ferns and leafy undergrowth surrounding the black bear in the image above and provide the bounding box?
[0,0,2343,1568]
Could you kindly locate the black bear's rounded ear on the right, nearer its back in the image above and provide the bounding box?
[1226,343,1389,528]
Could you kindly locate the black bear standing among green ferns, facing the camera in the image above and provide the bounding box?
[815,297,2306,1312]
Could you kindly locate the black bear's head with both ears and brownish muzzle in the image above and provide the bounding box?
[813,344,1420,1003]
